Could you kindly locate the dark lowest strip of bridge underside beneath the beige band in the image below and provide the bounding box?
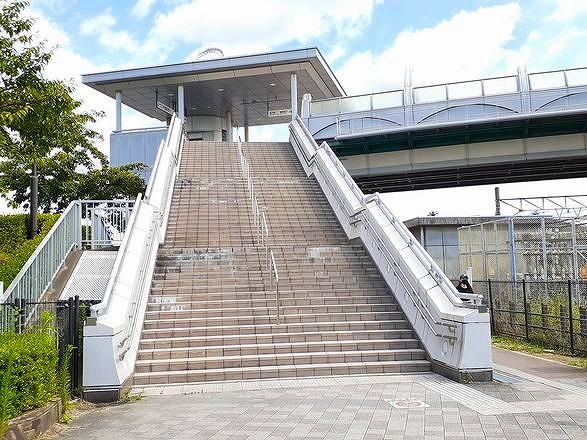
[355,156,587,193]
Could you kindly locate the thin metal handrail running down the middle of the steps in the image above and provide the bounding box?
[236,136,281,324]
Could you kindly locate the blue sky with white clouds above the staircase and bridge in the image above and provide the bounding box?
[20,0,587,216]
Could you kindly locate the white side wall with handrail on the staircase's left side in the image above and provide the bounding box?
[83,115,184,398]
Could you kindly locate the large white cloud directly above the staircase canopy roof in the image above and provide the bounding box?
[145,0,377,59]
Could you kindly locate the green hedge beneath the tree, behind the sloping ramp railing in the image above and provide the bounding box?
[0,214,59,289]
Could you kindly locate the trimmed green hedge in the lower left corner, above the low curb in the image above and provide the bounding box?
[0,329,59,427]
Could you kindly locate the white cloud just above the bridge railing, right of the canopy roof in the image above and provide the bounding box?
[338,3,520,93]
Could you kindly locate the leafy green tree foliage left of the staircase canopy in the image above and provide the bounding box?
[0,0,144,215]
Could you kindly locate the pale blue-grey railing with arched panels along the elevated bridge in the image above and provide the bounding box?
[307,68,587,138]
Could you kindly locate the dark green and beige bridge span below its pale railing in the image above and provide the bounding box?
[320,114,587,192]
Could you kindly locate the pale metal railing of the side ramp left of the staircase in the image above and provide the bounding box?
[0,200,133,304]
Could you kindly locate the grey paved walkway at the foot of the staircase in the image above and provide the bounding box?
[60,350,587,440]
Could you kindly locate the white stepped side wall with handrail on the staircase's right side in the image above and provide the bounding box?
[290,117,492,377]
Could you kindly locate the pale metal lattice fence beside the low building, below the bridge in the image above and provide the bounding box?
[458,216,587,281]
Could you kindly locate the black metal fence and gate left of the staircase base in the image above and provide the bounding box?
[0,296,98,393]
